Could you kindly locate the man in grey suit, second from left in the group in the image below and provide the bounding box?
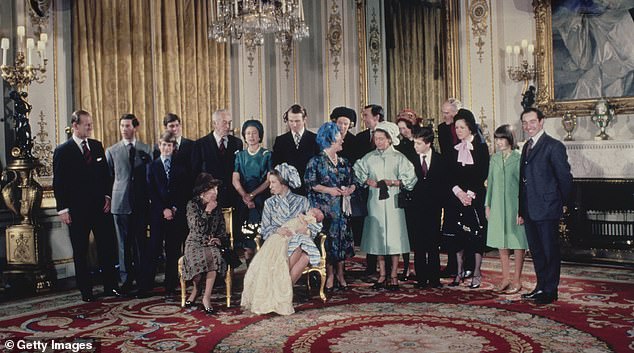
[106,114,152,293]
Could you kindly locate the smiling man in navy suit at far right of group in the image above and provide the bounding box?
[519,108,572,304]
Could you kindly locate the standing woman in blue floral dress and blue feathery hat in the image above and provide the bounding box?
[304,122,356,291]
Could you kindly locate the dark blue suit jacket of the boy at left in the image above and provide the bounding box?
[147,158,188,214]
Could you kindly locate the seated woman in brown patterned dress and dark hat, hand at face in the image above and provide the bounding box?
[183,173,227,314]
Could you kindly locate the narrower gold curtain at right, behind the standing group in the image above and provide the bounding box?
[385,0,448,125]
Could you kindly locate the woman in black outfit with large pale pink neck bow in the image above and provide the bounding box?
[443,109,489,288]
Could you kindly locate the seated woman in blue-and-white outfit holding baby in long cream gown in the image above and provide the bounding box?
[240,163,324,315]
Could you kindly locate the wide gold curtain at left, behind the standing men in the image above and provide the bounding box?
[72,0,229,146]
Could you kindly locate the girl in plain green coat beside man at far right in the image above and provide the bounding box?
[484,125,528,294]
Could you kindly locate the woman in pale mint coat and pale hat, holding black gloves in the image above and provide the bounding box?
[354,121,417,289]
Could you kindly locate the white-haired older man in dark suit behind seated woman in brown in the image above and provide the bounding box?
[192,109,243,208]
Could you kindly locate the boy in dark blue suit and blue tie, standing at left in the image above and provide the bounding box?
[137,131,188,298]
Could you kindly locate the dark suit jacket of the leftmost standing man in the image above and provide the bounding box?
[53,138,112,212]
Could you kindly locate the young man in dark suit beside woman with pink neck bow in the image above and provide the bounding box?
[412,127,449,289]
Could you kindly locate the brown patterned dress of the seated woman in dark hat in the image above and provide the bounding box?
[183,198,227,281]
